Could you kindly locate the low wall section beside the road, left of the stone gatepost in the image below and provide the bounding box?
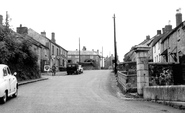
[118,71,137,92]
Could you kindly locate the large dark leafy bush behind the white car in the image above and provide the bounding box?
[0,28,40,81]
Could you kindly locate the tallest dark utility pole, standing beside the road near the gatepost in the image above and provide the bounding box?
[113,14,117,74]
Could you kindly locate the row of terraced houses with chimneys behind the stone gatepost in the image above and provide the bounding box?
[124,10,185,64]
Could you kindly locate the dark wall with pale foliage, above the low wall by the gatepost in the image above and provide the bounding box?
[148,63,185,86]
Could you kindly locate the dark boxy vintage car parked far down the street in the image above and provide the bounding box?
[67,63,80,75]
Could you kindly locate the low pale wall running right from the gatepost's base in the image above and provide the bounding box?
[143,85,185,102]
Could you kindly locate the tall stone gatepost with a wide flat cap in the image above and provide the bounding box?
[134,45,150,95]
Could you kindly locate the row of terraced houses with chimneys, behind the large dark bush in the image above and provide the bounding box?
[0,15,68,72]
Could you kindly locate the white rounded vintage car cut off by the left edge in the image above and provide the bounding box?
[0,64,18,103]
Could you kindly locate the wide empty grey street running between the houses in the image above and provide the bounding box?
[0,70,185,113]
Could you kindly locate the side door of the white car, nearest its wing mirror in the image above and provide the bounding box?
[3,67,11,93]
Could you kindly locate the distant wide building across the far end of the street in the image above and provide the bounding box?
[68,48,102,69]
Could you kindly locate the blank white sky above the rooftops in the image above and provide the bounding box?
[0,0,185,62]
